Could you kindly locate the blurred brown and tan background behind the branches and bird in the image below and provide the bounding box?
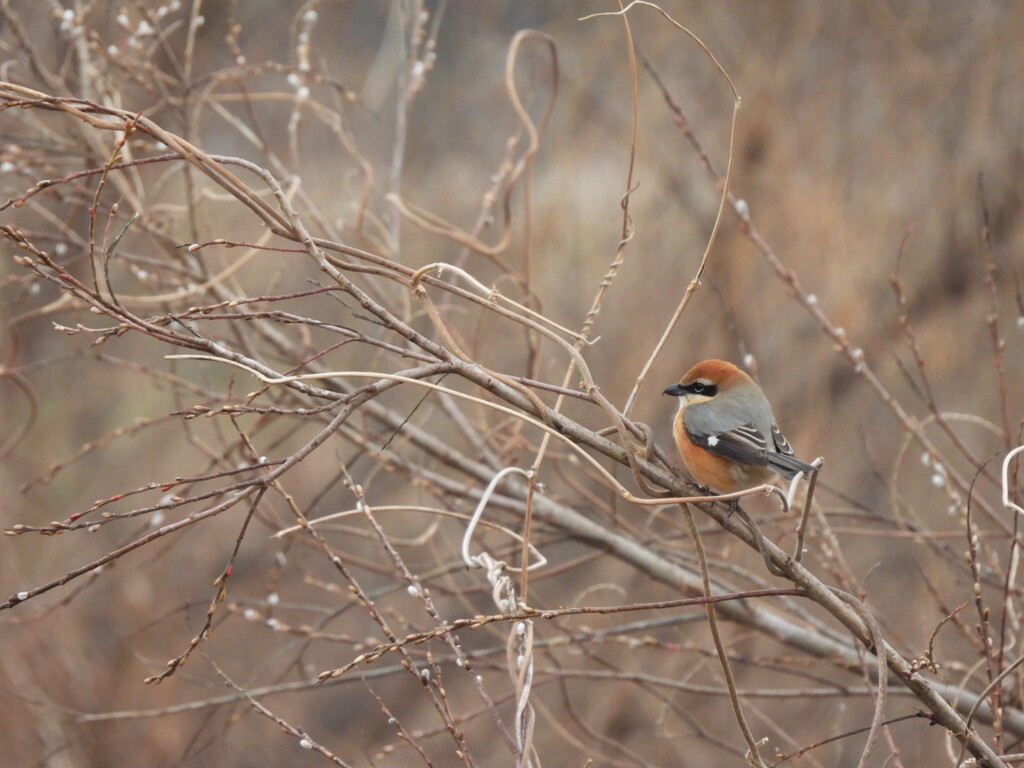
[0,0,1024,766]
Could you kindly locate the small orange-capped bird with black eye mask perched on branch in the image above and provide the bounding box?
[665,360,816,494]
